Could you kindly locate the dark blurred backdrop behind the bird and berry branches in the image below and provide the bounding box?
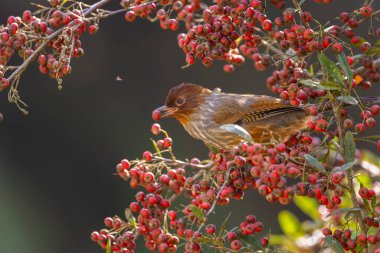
[0,0,379,253]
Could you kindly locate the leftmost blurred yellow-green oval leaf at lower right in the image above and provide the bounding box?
[278,210,304,238]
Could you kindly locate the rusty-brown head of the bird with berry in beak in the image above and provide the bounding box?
[152,83,212,124]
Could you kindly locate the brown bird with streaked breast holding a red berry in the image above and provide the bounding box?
[152,83,378,149]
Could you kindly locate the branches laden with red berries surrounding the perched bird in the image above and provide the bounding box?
[0,0,380,253]
